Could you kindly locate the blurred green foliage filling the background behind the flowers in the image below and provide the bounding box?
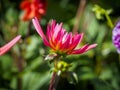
[0,0,120,90]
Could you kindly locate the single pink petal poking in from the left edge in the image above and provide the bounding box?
[0,35,21,56]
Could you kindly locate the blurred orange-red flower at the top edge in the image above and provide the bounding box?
[20,0,47,21]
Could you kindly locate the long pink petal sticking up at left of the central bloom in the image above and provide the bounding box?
[32,17,49,46]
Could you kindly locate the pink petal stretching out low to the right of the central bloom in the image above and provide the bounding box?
[69,44,97,54]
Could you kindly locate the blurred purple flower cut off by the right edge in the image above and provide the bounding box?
[112,22,120,54]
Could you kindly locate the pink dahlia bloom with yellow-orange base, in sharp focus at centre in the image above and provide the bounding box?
[32,18,97,55]
